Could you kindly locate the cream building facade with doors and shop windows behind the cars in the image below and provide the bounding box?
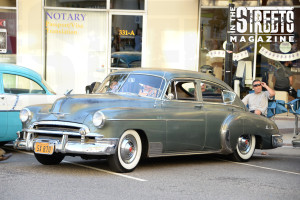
[0,0,300,97]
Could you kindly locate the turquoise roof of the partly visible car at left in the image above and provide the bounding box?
[0,63,42,80]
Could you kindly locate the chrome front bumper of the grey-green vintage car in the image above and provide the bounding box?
[14,132,119,155]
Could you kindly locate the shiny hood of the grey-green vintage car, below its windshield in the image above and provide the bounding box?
[37,93,155,123]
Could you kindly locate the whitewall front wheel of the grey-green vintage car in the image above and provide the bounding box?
[108,130,142,173]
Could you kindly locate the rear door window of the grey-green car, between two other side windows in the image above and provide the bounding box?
[201,82,223,103]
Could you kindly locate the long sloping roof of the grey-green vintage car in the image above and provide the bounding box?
[113,68,232,90]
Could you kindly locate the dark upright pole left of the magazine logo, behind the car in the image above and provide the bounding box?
[224,0,234,87]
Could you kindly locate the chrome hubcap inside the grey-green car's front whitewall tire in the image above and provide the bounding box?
[120,135,137,164]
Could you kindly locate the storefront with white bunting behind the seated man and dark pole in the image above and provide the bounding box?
[199,0,300,100]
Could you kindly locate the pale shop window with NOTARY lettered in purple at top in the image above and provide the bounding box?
[45,9,108,94]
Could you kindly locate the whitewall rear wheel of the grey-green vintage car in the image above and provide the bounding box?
[232,135,256,162]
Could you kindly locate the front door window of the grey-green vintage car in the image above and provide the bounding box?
[166,81,197,101]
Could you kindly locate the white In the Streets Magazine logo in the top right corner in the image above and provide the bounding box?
[230,7,295,42]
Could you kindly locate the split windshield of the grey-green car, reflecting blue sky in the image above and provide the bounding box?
[96,74,165,98]
